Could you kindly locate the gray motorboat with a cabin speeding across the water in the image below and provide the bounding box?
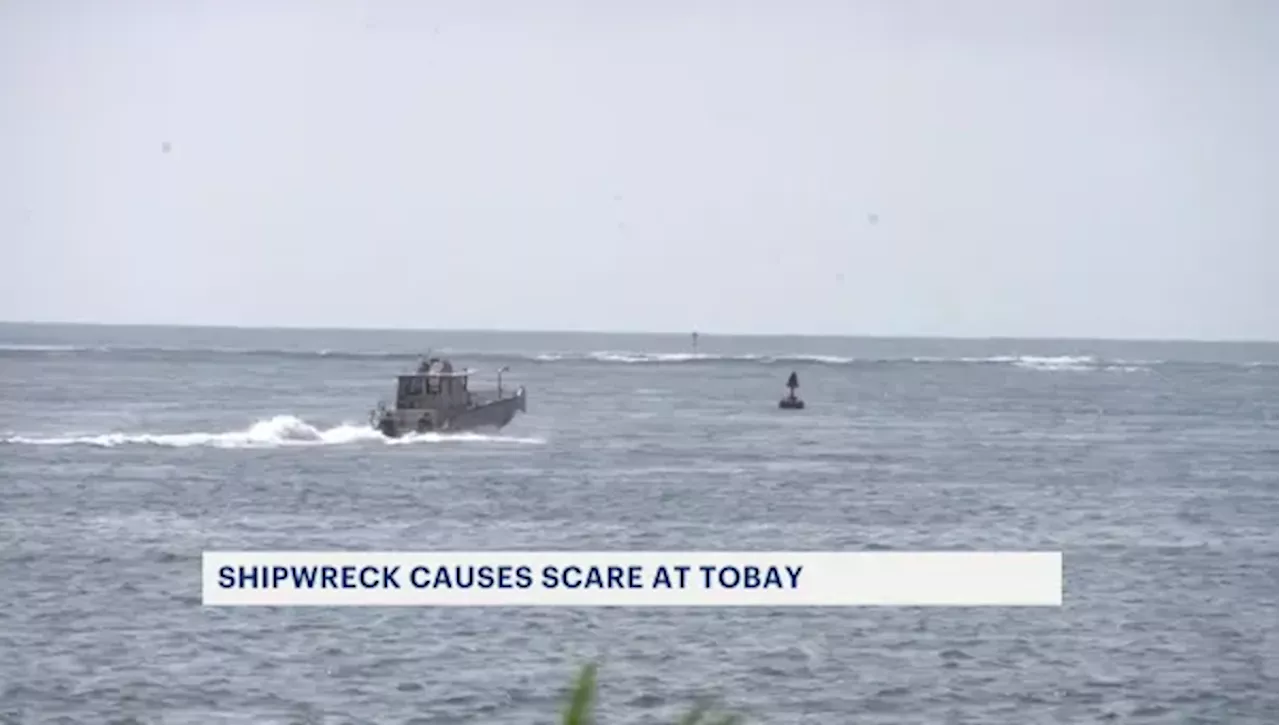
[369,357,525,438]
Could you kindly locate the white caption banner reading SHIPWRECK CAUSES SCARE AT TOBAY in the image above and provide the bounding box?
[202,552,1062,607]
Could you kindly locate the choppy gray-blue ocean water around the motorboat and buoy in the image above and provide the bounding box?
[0,325,1280,725]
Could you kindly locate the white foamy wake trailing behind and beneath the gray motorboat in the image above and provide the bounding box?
[0,415,545,448]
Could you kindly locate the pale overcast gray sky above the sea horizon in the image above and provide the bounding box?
[0,0,1280,339]
